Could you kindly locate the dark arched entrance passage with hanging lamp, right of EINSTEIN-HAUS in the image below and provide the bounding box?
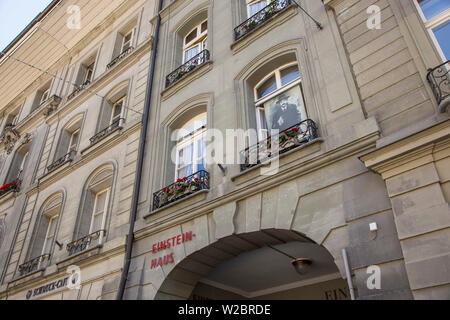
[155,229,350,300]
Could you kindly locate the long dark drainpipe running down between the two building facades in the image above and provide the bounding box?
[116,0,163,300]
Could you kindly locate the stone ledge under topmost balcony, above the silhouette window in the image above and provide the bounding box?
[230,3,297,54]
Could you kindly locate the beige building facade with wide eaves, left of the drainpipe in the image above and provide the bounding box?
[0,0,155,300]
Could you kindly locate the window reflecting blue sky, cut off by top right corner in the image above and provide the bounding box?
[416,0,450,60]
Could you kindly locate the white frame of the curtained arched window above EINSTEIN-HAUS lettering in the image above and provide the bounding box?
[175,113,206,181]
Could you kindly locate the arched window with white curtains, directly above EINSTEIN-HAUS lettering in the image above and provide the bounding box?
[175,113,206,180]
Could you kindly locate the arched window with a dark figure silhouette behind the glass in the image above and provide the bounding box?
[254,63,307,140]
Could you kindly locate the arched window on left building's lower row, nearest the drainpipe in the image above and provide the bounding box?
[69,166,114,255]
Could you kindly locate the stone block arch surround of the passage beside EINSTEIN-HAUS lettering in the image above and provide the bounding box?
[135,188,349,299]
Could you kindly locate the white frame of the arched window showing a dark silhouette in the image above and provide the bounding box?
[253,62,307,141]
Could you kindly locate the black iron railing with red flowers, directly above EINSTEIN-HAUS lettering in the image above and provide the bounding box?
[153,170,209,210]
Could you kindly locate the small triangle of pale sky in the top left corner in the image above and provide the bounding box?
[0,0,52,50]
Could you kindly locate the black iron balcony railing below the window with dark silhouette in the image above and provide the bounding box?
[240,119,318,171]
